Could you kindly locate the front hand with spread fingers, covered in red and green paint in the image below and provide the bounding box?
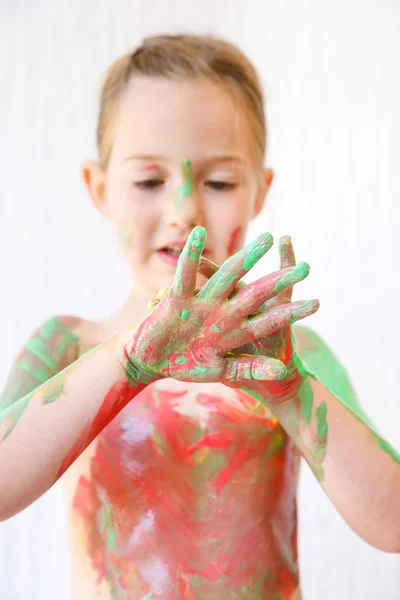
[117,227,318,385]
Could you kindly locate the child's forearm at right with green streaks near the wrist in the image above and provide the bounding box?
[252,377,400,552]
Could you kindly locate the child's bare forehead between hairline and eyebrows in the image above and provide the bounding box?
[113,77,250,160]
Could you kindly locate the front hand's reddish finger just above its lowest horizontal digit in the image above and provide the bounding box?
[220,300,319,349]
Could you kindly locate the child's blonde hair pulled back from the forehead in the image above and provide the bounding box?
[97,34,266,169]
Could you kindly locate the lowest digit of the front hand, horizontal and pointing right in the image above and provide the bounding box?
[222,354,287,384]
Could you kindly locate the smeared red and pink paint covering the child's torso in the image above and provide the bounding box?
[73,382,299,600]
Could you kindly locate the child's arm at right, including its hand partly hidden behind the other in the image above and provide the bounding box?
[199,241,400,552]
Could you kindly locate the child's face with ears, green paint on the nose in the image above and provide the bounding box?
[83,77,272,297]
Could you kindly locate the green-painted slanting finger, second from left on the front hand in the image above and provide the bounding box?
[198,233,273,300]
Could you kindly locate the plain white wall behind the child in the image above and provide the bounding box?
[0,0,400,600]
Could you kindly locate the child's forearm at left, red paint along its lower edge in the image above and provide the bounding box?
[0,333,151,520]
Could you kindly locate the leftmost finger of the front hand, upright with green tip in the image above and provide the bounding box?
[170,226,207,296]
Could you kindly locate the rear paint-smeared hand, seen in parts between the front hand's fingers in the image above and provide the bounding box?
[199,236,319,405]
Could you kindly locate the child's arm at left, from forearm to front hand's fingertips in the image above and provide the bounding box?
[0,227,318,519]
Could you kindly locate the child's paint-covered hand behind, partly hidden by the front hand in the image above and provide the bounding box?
[199,236,319,402]
